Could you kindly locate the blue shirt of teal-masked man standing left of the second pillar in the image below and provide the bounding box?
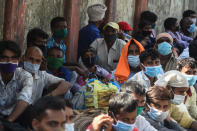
[47,37,66,62]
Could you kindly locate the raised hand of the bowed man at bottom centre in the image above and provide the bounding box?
[91,114,113,131]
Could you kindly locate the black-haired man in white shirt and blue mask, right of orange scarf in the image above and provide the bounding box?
[128,49,163,91]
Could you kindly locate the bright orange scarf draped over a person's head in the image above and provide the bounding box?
[114,39,144,83]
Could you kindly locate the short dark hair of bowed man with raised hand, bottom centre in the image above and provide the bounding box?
[108,92,137,115]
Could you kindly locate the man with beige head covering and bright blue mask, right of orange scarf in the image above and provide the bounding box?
[155,33,177,72]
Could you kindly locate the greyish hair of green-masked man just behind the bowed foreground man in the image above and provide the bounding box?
[120,81,146,96]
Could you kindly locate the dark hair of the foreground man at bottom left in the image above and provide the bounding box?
[32,96,65,121]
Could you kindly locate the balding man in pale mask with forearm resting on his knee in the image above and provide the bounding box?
[24,47,71,103]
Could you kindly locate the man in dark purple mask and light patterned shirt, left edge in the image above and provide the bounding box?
[0,41,33,122]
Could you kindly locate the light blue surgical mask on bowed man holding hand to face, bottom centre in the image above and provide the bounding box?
[112,113,135,131]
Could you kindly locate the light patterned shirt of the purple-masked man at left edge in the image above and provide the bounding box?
[0,68,33,115]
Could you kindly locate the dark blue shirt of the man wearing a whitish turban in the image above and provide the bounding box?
[78,24,101,58]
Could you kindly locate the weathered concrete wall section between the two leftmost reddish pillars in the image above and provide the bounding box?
[25,0,64,39]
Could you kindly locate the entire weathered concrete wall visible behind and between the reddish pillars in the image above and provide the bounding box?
[0,0,197,44]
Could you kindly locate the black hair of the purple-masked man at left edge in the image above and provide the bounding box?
[0,40,21,58]
